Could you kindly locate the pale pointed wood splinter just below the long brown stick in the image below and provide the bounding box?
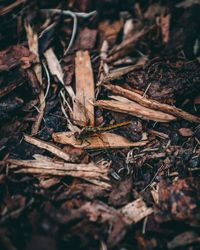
[94,98,176,122]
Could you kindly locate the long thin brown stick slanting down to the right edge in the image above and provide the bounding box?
[104,84,200,123]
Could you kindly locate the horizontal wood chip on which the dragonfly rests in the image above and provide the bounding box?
[52,132,147,149]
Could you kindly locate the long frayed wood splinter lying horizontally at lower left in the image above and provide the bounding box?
[7,155,110,189]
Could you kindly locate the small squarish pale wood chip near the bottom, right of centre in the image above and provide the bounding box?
[120,198,153,225]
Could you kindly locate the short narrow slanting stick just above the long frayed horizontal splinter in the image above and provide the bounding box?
[24,135,76,162]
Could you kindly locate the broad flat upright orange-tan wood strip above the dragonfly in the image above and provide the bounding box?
[73,51,95,126]
